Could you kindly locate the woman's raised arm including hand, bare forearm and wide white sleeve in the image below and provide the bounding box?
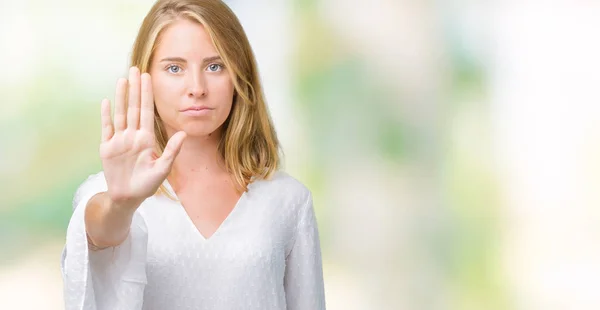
[61,67,185,310]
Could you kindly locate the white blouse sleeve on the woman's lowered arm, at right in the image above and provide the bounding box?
[284,192,325,310]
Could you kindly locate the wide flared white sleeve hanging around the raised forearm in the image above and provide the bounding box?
[61,172,148,310]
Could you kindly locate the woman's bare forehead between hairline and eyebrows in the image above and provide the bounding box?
[155,19,218,61]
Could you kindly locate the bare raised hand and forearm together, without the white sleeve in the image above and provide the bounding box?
[83,67,180,249]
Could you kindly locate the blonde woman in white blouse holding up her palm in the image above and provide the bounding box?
[61,0,325,310]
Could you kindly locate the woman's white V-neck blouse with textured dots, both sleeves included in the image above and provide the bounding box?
[61,171,325,310]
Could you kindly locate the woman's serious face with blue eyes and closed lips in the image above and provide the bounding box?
[149,20,234,137]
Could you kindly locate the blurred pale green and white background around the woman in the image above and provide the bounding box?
[0,0,600,310]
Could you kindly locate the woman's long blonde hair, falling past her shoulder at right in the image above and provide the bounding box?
[131,0,280,198]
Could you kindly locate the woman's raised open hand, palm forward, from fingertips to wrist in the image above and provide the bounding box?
[100,67,185,208]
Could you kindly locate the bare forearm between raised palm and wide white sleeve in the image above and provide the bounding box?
[85,192,141,250]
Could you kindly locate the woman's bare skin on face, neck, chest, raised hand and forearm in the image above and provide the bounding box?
[85,20,241,248]
